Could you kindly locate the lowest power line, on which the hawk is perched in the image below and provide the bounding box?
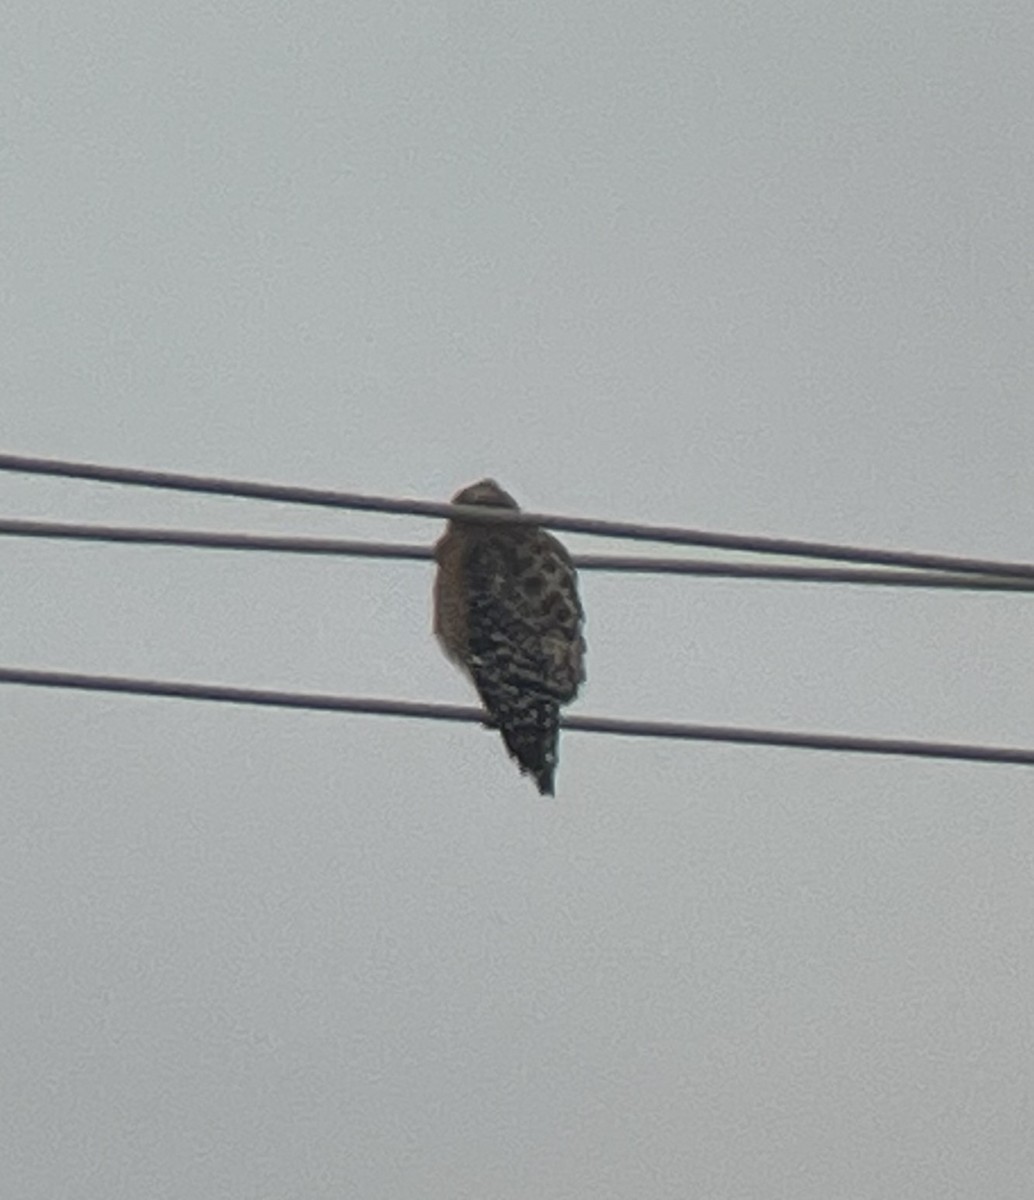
[0,667,1034,767]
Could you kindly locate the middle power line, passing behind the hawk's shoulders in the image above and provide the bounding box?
[0,518,1034,592]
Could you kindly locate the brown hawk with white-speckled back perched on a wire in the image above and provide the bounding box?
[434,479,585,796]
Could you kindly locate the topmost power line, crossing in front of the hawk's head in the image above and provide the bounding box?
[0,455,1034,578]
